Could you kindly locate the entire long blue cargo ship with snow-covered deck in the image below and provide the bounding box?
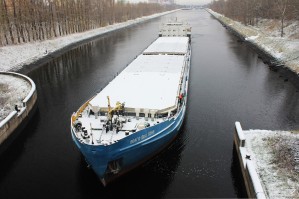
[71,21,191,186]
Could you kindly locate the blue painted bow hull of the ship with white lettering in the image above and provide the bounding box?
[71,104,187,185]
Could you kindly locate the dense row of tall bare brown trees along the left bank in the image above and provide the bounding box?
[0,0,173,46]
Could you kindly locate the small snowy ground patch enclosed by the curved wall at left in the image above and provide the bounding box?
[0,74,31,121]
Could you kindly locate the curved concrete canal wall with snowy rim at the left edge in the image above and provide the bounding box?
[0,72,37,154]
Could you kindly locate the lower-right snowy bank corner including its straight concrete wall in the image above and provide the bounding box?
[234,122,299,198]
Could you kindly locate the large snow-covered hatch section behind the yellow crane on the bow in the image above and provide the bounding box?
[90,55,184,110]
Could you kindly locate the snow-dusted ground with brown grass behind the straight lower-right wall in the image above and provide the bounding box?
[243,130,299,198]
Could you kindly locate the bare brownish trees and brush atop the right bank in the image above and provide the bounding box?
[210,0,299,37]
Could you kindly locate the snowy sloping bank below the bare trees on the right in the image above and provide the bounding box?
[208,10,299,74]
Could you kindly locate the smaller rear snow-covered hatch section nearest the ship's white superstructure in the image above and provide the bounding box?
[143,37,189,54]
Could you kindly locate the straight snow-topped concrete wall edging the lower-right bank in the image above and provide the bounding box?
[234,122,267,199]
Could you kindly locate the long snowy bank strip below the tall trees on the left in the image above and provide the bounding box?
[0,10,176,71]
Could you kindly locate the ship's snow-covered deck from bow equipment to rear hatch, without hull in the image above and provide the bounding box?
[73,37,191,145]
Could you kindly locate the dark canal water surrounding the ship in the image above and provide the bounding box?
[0,10,299,199]
